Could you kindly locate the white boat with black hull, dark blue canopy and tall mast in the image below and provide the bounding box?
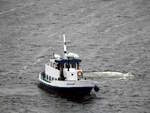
[38,34,99,96]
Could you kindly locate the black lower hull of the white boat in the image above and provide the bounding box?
[38,82,92,96]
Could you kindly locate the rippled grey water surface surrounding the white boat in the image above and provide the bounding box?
[0,0,150,113]
